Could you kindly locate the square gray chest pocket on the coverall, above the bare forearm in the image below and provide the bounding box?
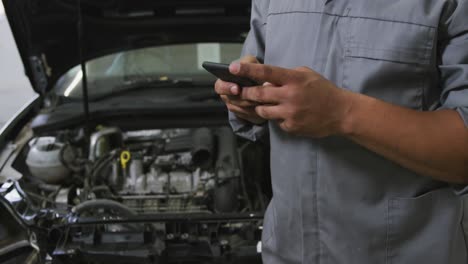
[342,17,435,109]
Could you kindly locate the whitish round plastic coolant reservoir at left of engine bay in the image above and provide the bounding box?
[26,137,70,184]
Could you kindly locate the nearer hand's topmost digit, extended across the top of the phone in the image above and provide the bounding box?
[229,62,298,85]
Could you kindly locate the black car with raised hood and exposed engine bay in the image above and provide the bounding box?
[0,0,271,263]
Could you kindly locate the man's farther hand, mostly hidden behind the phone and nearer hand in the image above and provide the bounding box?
[215,56,265,124]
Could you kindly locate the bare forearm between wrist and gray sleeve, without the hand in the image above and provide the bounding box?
[343,93,468,183]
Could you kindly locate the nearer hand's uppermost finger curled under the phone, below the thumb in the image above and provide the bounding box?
[240,86,284,104]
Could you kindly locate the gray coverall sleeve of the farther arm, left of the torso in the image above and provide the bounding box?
[229,0,269,141]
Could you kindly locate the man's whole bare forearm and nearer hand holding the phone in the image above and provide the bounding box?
[230,63,468,184]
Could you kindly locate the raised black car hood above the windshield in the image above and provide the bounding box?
[3,0,251,94]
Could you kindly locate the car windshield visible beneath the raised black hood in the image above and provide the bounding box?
[54,43,242,99]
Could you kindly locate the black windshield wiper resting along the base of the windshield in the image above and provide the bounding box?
[90,77,193,102]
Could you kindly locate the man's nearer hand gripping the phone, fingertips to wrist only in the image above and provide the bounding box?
[230,62,353,138]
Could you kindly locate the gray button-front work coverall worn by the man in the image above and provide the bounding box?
[230,0,468,264]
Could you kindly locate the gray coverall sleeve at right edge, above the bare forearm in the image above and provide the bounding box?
[438,0,468,127]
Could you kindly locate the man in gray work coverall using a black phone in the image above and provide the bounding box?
[215,0,468,264]
